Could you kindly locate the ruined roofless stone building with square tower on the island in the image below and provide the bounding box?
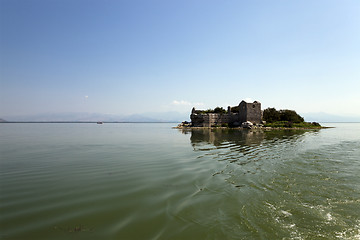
[190,101,262,127]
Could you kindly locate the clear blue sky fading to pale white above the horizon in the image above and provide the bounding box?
[0,0,360,118]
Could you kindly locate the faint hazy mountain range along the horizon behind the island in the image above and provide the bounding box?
[0,112,360,122]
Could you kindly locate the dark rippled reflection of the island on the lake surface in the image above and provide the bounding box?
[180,128,318,168]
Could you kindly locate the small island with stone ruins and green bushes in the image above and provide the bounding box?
[176,100,325,129]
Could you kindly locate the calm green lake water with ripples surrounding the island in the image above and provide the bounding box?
[0,123,360,240]
